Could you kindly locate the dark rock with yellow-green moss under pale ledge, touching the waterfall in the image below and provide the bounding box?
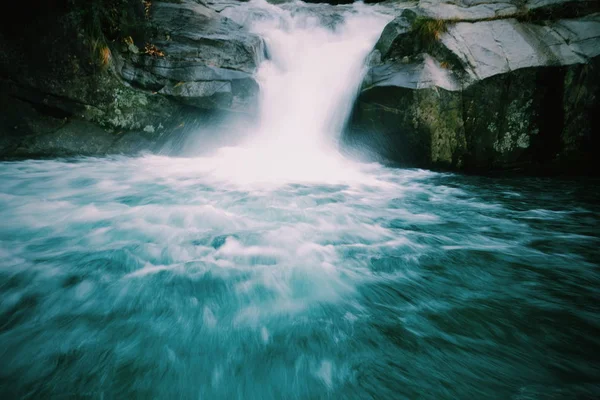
[347,86,466,167]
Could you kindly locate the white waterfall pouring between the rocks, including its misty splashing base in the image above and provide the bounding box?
[199,0,389,182]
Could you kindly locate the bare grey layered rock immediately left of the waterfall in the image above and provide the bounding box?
[120,1,265,111]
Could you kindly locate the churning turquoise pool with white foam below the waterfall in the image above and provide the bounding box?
[0,157,600,399]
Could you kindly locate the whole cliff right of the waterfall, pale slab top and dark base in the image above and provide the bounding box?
[348,0,600,171]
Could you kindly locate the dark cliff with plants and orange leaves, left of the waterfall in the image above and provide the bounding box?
[0,0,264,156]
